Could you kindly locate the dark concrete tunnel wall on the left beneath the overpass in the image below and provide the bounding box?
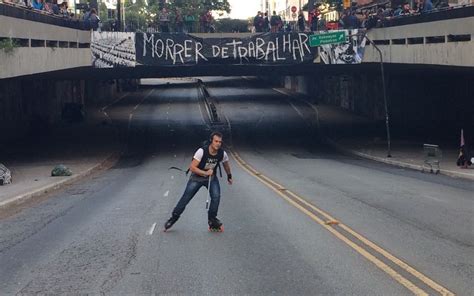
[0,79,134,144]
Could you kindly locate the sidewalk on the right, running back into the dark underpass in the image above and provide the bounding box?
[275,88,474,181]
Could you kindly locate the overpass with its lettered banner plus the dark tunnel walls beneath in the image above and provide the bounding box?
[0,0,474,162]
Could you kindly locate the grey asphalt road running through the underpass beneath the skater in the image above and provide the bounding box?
[0,78,474,295]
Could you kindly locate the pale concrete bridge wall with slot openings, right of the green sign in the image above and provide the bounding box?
[363,17,474,67]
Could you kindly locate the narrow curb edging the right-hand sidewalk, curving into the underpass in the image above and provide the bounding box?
[273,88,474,181]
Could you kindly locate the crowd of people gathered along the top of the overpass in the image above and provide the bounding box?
[2,0,464,33]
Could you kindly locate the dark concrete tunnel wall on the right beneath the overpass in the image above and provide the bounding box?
[280,69,474,141]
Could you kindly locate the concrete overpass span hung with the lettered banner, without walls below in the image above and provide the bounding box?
[0,3,474,79]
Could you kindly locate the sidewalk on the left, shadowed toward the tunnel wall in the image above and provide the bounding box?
[0,111,119,209]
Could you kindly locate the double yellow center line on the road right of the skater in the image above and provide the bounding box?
[231,151,454,295]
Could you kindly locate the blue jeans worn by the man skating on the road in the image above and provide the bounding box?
[173,176,221,219]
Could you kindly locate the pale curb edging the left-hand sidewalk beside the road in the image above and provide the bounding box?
[0,152,120,209]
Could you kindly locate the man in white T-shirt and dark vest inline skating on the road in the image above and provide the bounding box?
[165,132,232,231]
